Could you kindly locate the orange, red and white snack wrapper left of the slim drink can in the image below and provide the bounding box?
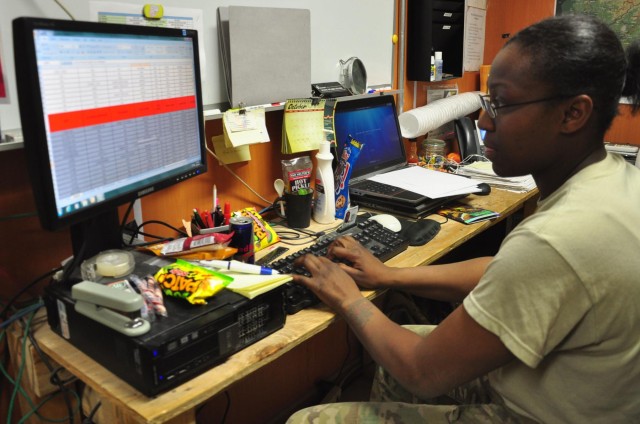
[144,233,238,260]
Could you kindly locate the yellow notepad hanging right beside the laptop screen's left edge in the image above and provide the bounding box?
[282,99,325,154]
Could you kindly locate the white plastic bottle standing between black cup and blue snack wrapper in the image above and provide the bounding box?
[313,141,336,224]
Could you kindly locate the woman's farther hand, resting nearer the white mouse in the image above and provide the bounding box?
[327,236,394,289]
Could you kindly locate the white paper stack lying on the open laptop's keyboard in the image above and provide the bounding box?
[368,166,481,199]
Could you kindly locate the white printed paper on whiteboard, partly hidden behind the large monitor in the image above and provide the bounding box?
[89,1,207,82]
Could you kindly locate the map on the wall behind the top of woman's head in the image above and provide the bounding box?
[556,0,640,47]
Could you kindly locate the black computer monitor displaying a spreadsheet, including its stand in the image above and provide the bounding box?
[13,18,207,259]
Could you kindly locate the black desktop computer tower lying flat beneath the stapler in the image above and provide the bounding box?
[45,274,286,396]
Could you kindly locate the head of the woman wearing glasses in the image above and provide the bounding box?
[478,15,640,191]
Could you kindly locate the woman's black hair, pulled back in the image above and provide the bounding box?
[506,15,640,134]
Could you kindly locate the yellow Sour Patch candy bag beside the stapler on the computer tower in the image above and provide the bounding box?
[155,259,233,305]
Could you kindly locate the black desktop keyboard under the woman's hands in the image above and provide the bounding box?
[269,220,409,315]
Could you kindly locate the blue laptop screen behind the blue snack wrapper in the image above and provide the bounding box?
[333,95,406,179]
